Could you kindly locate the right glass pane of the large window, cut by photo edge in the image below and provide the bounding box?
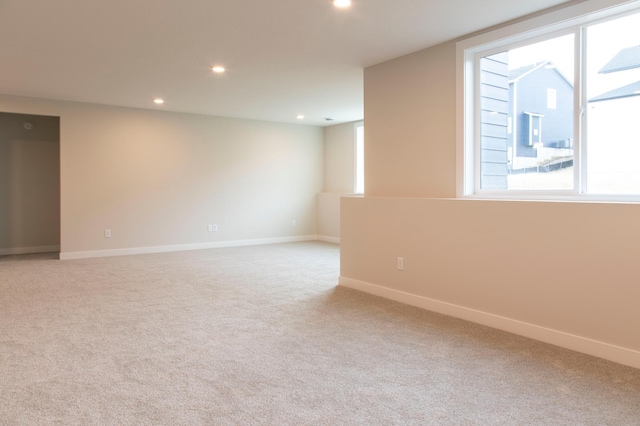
[586,14,640,194]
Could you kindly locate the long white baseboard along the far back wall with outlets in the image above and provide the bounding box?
[60,235,317,260]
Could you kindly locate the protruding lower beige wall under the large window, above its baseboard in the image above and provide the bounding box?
[341,198,640,360]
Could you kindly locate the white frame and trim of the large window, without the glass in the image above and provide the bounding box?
[456,0,640,202]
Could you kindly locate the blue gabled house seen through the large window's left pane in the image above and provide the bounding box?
[507,61,573,172]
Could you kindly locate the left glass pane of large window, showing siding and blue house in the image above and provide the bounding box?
[480,34,575,190]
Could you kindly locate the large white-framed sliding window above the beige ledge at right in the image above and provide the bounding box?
[459,1,640,198]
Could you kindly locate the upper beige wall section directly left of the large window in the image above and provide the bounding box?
[364,42,456,197]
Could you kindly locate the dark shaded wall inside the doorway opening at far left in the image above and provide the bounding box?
[0,113,60,255]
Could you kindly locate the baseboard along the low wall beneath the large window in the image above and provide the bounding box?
[339,276,640,368]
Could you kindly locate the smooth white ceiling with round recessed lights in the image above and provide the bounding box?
[0,0,567,126]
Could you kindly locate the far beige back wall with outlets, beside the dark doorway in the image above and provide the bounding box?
[0,96,324,257]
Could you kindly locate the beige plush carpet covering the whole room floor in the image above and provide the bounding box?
[0,242,640,425]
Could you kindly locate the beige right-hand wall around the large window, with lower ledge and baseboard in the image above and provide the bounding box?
[340,35,640,367]
